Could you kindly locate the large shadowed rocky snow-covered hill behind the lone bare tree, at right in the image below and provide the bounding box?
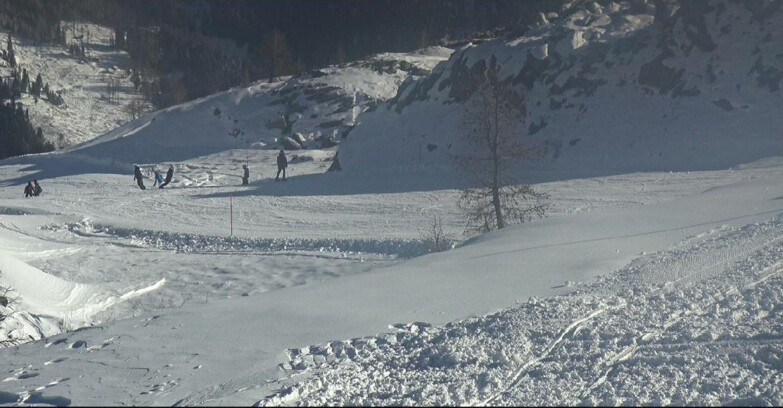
[340,0,783,179]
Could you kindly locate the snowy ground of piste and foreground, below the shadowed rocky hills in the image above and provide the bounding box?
[0,147,783,405]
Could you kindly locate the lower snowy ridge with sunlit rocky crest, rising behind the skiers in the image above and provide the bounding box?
[56,47,452,170]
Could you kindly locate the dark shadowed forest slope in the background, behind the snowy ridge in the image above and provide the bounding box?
[0,0,561,108]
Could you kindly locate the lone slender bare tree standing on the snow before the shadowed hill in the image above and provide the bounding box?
[457,56,549,233]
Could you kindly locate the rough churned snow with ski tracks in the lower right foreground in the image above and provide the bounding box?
[258,215,783,406]
